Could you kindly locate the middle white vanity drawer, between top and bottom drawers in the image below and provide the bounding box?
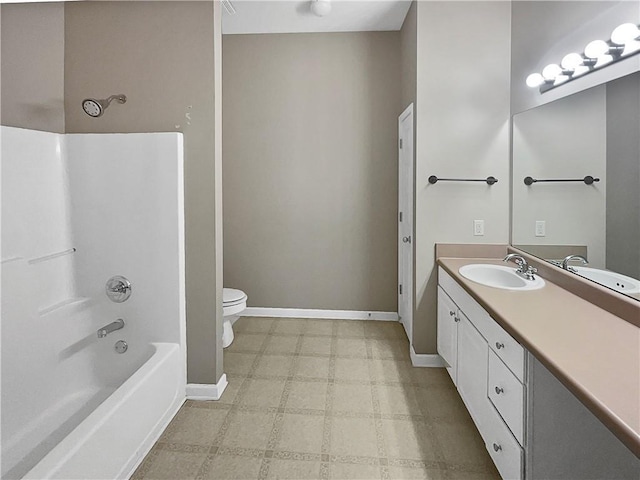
[487,350,524,445]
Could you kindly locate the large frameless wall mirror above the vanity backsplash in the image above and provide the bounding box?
[511,72,640,300]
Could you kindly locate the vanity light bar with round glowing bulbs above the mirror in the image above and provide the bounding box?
[526,23,640,93]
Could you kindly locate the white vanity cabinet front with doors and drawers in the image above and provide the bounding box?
[438,268,526,479]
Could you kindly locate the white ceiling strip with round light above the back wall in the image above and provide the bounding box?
[222,0,411,34]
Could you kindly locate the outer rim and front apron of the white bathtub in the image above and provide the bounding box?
[24,343,185,480]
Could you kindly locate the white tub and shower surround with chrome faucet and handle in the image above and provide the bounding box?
[1,126,186,479]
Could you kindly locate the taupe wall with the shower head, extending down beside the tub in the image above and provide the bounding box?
[65,2,222,383]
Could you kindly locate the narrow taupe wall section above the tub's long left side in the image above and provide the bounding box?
[0,3,64,133]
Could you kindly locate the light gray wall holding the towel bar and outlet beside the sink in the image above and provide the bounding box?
[413,1,511,354]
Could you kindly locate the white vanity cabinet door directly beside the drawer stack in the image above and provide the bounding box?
[457,312,492,437]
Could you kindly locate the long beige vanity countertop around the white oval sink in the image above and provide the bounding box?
[438,258,640,457]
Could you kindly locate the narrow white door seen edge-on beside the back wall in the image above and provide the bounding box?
[398,104,413,343]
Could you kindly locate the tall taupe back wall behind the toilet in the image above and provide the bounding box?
[223,32,401,312]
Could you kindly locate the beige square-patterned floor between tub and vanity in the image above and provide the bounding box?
[132,317,499,480]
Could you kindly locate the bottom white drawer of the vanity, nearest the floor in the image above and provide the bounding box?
[483,409,524,480]
